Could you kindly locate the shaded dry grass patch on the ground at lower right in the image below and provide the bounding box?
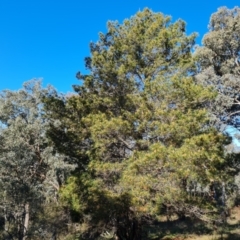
[143,207,240,240]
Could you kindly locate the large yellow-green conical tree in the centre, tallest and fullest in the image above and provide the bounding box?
[45,9,237,240]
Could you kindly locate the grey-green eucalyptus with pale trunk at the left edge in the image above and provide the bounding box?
[0,80,73,240]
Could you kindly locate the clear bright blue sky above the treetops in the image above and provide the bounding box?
[0,0,240,92]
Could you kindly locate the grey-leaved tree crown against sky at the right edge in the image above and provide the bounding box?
[195,7,240,129]
